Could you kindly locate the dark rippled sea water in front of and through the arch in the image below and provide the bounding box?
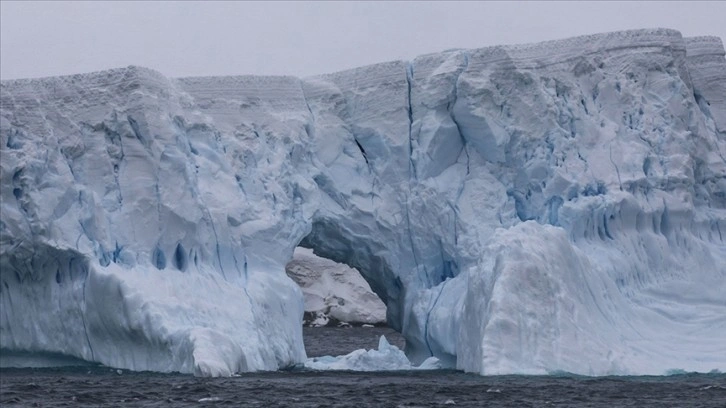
[0,327,726,408]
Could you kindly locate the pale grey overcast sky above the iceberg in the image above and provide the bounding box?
[0,0,726,79]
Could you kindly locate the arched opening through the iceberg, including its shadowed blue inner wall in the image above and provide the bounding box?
[285,220,409,362]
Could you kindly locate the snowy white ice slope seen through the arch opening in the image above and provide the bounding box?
[285,247,386,326]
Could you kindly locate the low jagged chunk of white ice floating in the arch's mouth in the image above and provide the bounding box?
[305,336,442,371]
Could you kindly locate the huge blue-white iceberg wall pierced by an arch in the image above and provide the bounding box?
[0,29,726,375]
